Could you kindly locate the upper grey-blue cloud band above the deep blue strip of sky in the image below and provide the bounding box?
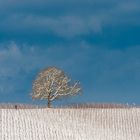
[0,0,140,40]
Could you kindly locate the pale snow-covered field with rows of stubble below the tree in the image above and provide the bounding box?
[0,108,140,140]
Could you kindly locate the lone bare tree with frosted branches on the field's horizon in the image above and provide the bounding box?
[31,67,81,107]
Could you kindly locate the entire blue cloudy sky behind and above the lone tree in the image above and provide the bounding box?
[0,0,140,104]
